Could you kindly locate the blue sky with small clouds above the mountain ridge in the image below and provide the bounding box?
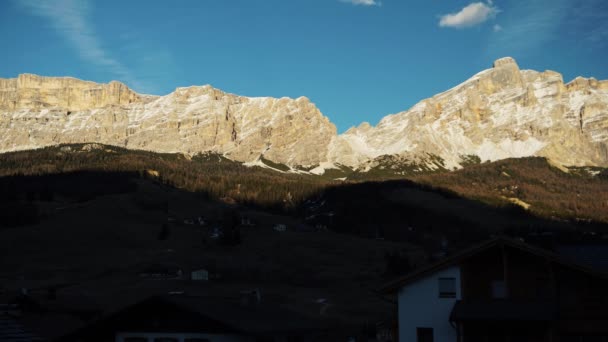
[0,0,608,132]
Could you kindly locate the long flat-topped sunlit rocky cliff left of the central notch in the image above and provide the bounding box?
[0,75,336,166]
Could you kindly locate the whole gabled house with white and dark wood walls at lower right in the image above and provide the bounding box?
[382,238,608,342]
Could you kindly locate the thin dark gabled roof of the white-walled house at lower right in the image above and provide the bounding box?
[380,237,608,294]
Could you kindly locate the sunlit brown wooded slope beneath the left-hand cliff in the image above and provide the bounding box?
[0,144,327,208]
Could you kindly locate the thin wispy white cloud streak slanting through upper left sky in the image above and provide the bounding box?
[16,0,143,89]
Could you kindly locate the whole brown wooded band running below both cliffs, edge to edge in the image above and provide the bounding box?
[0,144,608,225]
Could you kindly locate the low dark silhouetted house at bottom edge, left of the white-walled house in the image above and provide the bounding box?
[57,295,328,342]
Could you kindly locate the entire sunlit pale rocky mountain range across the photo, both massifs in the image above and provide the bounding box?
[0,57,608,172]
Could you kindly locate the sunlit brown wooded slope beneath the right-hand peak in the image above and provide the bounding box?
[412,157,608,222]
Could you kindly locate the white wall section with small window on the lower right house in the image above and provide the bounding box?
[398,267,461,342]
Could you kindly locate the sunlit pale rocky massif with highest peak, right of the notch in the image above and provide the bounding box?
[329,57,608,168]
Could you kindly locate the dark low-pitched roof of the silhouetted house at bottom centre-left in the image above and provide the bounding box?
[59,295,329,341]
